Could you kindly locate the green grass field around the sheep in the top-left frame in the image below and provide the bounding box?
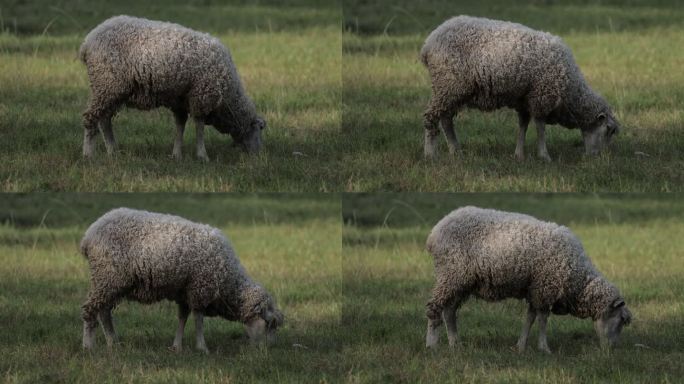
[0,0,341,192]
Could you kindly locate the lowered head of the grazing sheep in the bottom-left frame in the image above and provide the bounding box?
[244,287,284,344]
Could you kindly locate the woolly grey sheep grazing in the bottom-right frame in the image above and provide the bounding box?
[426,206,632,353]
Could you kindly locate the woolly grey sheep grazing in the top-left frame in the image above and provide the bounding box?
[79,16,266,161]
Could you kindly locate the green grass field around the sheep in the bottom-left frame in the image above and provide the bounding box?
[0,194,343,383]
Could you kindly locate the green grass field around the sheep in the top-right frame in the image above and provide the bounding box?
[342,0,684,192]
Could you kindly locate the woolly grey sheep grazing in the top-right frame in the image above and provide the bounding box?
[420,16,620,161]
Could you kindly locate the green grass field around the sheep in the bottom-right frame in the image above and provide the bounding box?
[342,193,684,383]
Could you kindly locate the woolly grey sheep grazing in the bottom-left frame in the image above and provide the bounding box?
[80,208,283,353]
